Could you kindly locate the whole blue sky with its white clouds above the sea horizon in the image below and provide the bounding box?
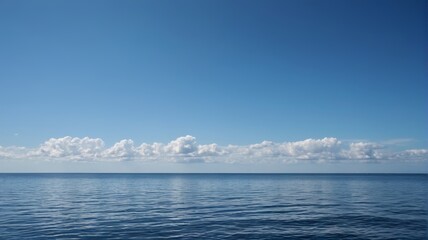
[0,0,428,173]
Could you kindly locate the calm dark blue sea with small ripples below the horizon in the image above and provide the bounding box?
[0,174,428,239]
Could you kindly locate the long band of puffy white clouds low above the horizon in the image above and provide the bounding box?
[0,135,428,163]
